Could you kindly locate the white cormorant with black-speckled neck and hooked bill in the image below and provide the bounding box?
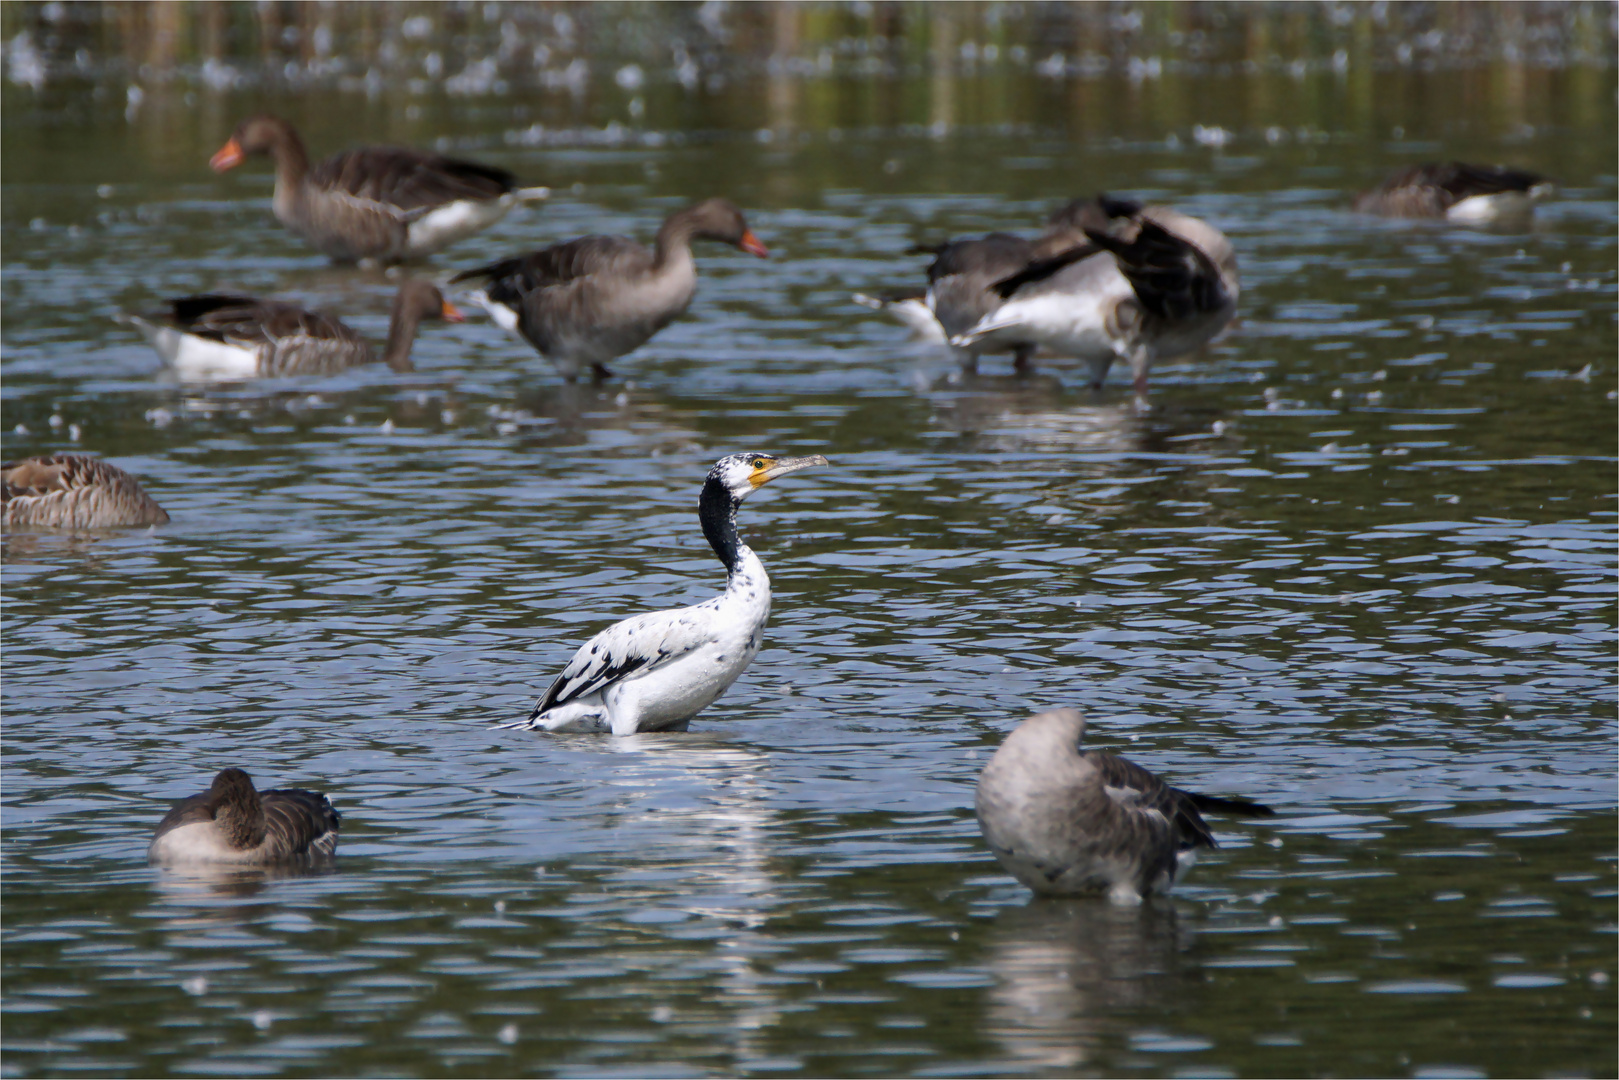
[500,453,829,735]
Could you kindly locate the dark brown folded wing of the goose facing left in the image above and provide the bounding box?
[309,146,516,214]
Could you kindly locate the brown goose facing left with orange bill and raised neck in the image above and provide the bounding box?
[209,115,550,262]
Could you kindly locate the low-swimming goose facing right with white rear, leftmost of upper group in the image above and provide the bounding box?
[121,280,463,379]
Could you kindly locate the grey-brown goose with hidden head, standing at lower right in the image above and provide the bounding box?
[976,709,1274,904]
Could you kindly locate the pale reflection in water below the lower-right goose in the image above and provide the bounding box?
[984,900,1183,1074]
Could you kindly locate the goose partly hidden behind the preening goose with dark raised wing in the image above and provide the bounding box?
[855,196,1140,371]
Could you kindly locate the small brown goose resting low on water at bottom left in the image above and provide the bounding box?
[146,769,342,866]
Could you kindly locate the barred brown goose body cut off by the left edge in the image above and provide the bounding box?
[0,453,168,529]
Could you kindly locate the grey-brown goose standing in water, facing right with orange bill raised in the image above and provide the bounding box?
[450,199,771,382]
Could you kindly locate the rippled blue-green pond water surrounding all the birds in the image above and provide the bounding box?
[0,2,1619,1077]
